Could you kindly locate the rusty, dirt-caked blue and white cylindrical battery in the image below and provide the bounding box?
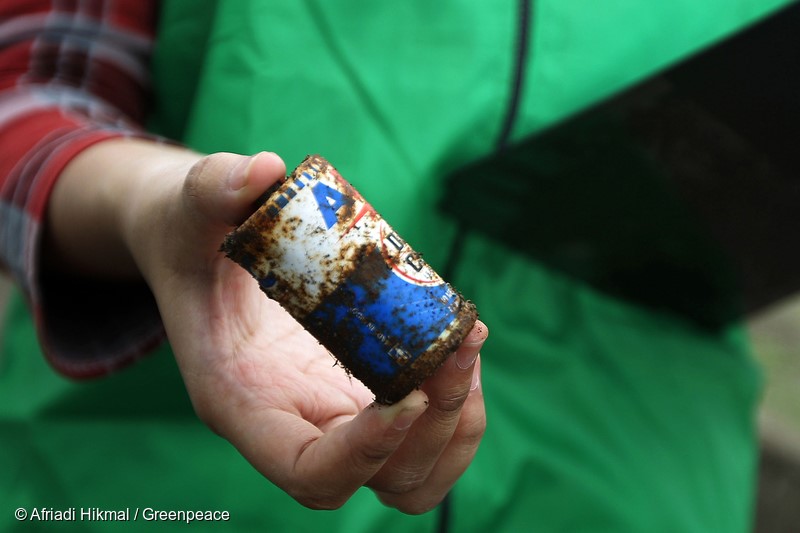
[222,156,477,403]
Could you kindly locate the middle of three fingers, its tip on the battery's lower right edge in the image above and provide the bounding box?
[369,321,488,494]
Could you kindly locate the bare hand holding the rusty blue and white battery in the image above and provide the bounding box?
[54,143,487,513]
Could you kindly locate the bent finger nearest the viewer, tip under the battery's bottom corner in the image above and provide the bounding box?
[223,390,427,509]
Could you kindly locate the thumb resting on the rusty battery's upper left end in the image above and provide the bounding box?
[183,152,286,231]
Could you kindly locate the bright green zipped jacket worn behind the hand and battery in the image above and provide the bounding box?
[0,0,785,533]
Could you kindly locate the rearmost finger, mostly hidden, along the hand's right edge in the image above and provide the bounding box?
[376,357,486,514]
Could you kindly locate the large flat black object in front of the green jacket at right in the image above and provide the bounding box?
[441,4,800,328]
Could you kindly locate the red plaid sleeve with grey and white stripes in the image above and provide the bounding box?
[0,0,164,377]
